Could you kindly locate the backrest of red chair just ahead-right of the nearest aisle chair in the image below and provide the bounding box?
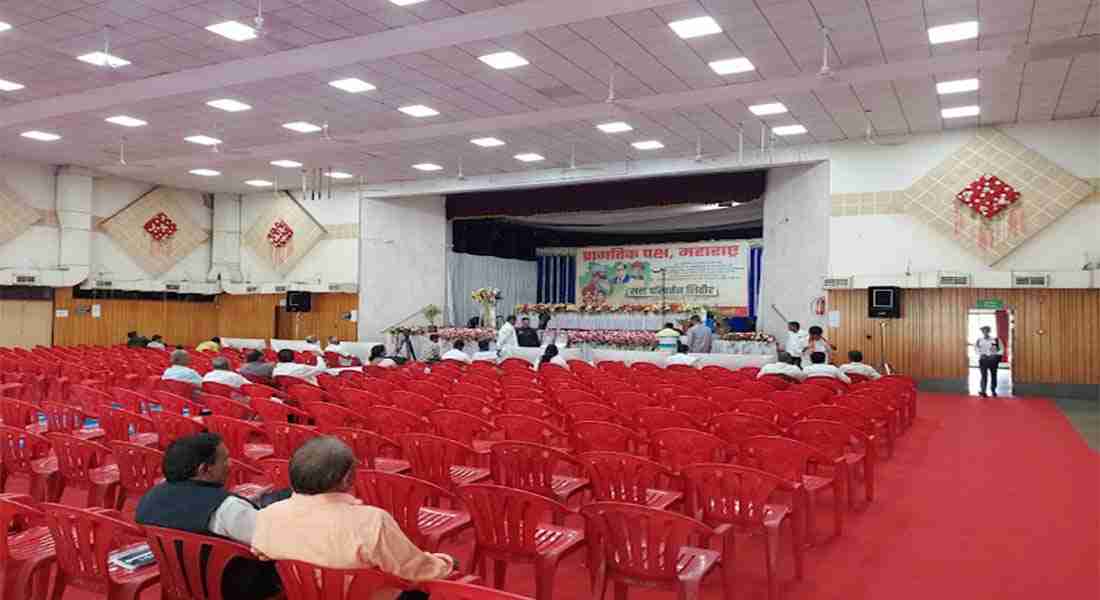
[682,462,784,526]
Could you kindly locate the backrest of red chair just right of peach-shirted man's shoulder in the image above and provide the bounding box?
[355,469,457,547]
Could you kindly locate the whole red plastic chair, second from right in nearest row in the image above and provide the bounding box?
[459,484,584,600]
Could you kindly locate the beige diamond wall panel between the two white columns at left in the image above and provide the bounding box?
[100,187,210,277]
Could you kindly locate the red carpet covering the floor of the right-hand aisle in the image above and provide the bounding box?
[10,394,1100,600]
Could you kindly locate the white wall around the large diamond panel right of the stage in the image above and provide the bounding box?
[827,119,1100,275]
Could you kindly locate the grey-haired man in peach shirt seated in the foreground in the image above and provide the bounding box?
[252,436,457,600]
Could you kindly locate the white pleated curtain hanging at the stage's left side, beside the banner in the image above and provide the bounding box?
[447,252,538,327]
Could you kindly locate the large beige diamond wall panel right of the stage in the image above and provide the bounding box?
[904,128,1093,265]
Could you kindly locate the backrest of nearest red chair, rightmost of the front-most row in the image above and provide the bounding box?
[581,502,715,583]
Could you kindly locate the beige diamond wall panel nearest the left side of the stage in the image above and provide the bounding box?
[243,194,328,275]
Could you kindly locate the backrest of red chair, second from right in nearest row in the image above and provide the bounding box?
[458,483,572,556]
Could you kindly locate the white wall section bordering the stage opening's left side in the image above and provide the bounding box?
[359,196,449,340]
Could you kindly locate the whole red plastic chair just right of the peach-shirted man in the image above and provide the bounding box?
[355,469,472,552]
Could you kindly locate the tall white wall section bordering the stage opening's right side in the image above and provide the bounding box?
[757,158,831,336]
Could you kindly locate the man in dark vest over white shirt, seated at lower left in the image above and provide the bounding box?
[135,433,282,600]
